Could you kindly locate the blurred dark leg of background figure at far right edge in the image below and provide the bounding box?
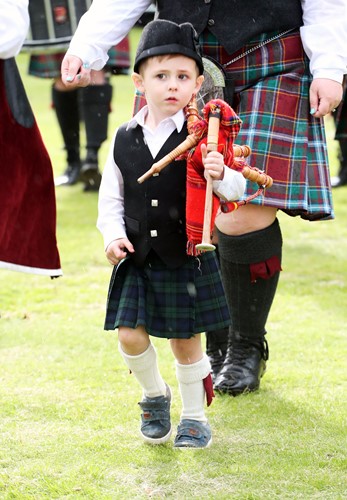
[331,77,347,187]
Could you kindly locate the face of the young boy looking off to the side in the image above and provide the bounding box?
[133,54,204,120]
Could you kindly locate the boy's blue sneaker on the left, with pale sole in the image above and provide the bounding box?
[139,385,171,444]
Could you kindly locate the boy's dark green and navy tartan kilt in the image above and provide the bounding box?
[105,252,230,339]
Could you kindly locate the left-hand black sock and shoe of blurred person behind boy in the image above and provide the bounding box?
[52,86,81,186]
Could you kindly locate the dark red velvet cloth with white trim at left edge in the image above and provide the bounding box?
[0,58,62,278]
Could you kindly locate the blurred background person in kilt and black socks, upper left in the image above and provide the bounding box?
[28,36,130,191]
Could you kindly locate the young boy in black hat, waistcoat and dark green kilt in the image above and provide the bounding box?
[97,20,245,448]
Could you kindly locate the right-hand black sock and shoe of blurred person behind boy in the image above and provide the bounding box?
[81,83,112,191]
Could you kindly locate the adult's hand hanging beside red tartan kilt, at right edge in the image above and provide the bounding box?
[310,78,343,118]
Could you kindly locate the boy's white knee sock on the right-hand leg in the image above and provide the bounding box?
[176,354,211,422]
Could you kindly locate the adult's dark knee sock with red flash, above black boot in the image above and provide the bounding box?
[218,219,282,342]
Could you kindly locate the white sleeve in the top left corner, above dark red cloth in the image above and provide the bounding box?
[0,0,30,59]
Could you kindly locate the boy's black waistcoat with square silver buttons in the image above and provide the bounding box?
[114,125,188,269]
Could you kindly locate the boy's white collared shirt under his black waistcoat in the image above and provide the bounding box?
[97,106,246,252]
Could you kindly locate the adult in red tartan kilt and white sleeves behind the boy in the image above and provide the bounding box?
[62,0,347,396]
